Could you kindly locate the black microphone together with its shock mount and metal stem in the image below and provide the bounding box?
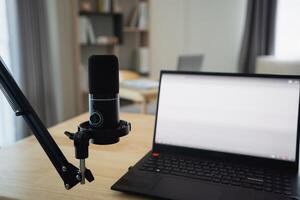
[65,55,131,184]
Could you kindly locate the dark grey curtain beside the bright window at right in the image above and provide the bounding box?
[239,0,277,73]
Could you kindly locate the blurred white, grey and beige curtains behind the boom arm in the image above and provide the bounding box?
[0,0,80,147]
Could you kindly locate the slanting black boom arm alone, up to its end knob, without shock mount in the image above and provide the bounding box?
[0,57,94,189]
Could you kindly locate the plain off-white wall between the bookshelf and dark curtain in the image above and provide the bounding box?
[150,0,246,77]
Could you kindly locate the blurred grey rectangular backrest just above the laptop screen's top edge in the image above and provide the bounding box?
[177,55,204,71]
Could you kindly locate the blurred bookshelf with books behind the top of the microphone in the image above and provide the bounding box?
[77,0,151,109]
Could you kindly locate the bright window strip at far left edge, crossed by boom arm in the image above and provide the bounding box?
[0,0,15,147]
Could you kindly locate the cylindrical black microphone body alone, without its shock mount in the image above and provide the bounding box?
[88,55,120,144]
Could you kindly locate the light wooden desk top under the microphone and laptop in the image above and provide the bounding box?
[0,113,154,200]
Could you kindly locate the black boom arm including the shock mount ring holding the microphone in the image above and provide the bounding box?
[0,57,131,190]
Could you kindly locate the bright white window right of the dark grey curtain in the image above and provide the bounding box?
[275,0,300,59]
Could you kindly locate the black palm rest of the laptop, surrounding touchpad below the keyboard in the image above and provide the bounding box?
[111,154,298,200]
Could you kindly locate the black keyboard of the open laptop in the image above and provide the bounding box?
[139,153,292,195]
